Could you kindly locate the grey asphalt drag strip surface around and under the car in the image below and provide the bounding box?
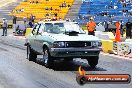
[0,30,132,88]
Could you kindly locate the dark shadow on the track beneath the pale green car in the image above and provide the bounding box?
[37,58,107,71]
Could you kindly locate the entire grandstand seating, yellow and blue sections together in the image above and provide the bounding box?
[0,0,132,24]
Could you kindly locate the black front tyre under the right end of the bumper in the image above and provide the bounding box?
[87,56,99,68]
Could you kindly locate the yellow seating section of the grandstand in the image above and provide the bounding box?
[10,0,74,19]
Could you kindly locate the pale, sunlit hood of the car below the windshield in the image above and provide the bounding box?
[49,34,100,41]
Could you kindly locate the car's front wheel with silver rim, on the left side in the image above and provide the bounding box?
[43,47,53,68]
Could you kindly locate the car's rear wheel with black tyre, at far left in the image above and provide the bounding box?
[27,46,37,62]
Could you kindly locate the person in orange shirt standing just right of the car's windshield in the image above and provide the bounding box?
[86,17,96,35]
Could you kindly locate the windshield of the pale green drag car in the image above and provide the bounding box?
[45,22,85,34]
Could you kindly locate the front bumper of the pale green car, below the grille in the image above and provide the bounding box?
[50,48,102,58]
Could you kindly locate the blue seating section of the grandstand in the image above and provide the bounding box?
[76,0,132,24]
